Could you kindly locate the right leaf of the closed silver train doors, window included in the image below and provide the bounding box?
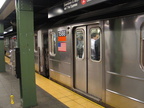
[87,23,103,99]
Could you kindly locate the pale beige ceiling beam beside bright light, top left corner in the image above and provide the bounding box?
[0,0,15,20]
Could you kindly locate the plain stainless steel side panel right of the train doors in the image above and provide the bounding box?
[104,16,144,108]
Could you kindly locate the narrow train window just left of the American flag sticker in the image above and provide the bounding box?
[50,32,56,56]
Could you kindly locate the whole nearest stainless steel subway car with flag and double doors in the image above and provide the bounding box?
[48,15,144,108]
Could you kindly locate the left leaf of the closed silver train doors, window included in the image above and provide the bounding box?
[75,27,87,92]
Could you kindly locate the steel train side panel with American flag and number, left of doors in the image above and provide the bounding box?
[49,26,73,87]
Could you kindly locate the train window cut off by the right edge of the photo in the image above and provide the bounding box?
[141,26,144,68]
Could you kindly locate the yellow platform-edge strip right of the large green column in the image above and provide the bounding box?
[35,73,104,108]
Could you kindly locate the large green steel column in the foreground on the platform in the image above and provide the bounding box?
[15,0,37,108]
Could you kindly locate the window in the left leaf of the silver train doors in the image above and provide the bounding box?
[75,29,85,59]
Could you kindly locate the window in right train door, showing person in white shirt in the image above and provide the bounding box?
[90,27,101,61]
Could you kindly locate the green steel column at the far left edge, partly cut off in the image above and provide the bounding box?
[0,22,5,72]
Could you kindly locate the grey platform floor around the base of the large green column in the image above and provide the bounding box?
[0,65,68,108]
